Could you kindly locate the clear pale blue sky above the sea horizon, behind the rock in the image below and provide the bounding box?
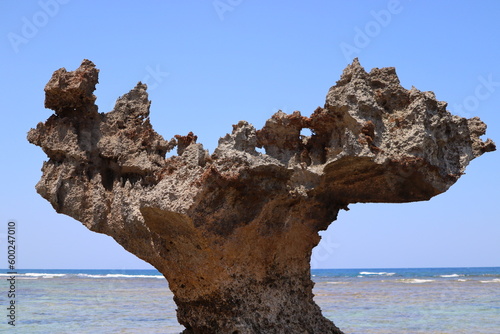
[0,0,500,269]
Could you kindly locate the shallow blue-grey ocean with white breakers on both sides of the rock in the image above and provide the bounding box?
[0,267,500,334]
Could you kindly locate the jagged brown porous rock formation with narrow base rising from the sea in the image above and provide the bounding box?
[28,59,495,334]
